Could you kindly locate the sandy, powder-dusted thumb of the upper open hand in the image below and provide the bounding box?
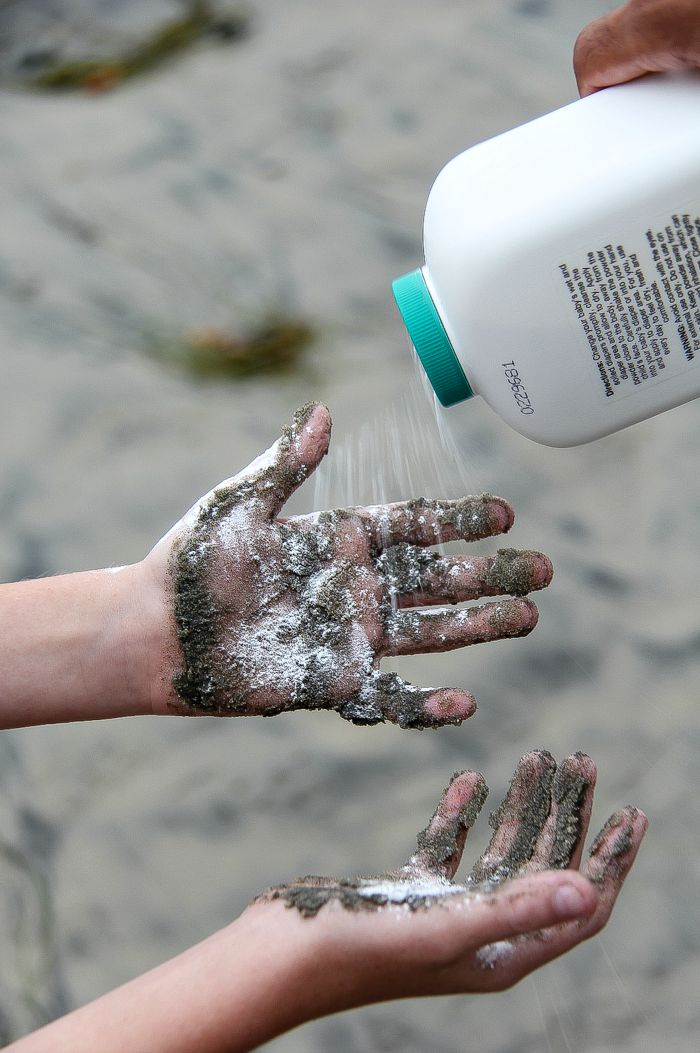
[251,402,331,519]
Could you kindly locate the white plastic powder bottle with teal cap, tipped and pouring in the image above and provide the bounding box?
[394,74,700,446]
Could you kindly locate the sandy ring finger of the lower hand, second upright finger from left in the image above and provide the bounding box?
[472,750,557,881]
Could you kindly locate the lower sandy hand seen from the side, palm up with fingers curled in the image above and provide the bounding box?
[258,750,646,999]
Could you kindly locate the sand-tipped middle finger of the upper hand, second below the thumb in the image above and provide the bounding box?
[376,543,553,608]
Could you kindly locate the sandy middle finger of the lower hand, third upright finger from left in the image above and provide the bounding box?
[525,753,596,870]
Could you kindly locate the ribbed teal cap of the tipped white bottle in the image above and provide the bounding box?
[392,270,474,405]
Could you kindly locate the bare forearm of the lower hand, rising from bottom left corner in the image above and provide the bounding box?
[11,903,341,1053]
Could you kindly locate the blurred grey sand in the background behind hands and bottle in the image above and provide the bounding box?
[0,0,700,1053]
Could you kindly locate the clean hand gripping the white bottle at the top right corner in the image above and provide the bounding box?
[574,0,700,96]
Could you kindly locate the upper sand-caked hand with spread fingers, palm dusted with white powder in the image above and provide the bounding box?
[147,404,552,728]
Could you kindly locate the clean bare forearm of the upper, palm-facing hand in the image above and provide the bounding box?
[0,564,165,728]
